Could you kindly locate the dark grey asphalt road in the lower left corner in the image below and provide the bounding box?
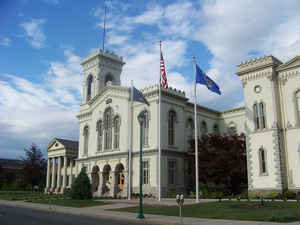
[0,205,151,225]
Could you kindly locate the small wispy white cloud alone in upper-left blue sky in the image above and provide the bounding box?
[21,19,46,49]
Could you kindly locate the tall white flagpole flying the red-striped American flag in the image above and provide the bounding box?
[157,41,162,201]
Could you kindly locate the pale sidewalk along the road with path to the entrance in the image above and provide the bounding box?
[0,199,300,225]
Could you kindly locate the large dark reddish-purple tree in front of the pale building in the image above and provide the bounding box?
[189,134,247,193]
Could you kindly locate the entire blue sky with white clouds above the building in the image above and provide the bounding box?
[0,0,300,158]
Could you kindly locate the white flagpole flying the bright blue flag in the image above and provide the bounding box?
[193,56,199,202]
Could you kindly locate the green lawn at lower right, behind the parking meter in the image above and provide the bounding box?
[114,201,300,222]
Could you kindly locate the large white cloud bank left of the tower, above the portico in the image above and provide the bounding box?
[0,49,82,157]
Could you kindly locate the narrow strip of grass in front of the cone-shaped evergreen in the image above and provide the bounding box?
[27,199,111,208]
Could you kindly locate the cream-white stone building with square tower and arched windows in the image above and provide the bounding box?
[46,50,300,196]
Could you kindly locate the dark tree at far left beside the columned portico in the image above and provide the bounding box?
[22,143,47,189]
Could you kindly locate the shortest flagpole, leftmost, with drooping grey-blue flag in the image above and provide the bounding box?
[127,80,133,200]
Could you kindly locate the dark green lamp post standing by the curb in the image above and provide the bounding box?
[136,111,145,219]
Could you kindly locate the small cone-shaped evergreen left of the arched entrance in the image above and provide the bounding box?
[70,168,92,199]
